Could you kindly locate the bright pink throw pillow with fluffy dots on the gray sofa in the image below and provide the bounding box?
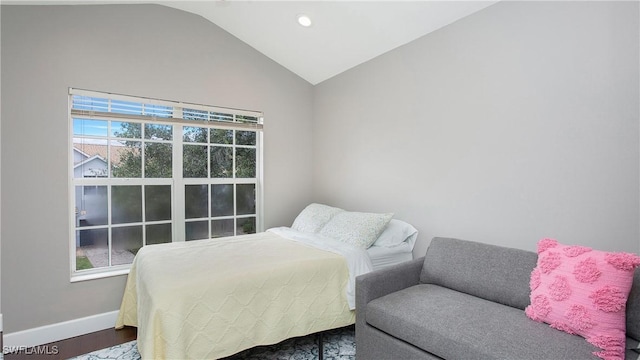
[525,239,640,359]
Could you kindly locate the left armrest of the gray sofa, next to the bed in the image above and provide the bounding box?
[356,257,424,322]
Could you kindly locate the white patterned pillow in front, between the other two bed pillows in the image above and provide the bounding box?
[320,211,393,249]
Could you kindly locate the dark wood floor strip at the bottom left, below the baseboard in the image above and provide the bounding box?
[4,326,137,360]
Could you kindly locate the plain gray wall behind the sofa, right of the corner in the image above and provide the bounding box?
[313,1,640,255]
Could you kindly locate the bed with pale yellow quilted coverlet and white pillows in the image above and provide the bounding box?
[116,204,417,359]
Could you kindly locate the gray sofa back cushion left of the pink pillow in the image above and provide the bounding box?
[420,238,538,309]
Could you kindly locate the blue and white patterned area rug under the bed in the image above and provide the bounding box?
[73,326,356,360]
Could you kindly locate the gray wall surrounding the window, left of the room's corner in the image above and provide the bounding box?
[1,5,313,333]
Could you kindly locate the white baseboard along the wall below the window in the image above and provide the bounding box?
[3,310,118,348]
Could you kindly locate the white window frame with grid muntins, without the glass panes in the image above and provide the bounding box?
[67,88,264,282]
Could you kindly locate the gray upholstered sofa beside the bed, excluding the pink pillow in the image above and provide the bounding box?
[356,238,640,360]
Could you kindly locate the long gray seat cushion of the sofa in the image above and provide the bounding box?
[366,284,598,359]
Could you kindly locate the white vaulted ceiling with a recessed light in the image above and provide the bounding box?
[0,0,499,85]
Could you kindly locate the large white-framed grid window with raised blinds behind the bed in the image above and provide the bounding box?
[69,89,262,281]
